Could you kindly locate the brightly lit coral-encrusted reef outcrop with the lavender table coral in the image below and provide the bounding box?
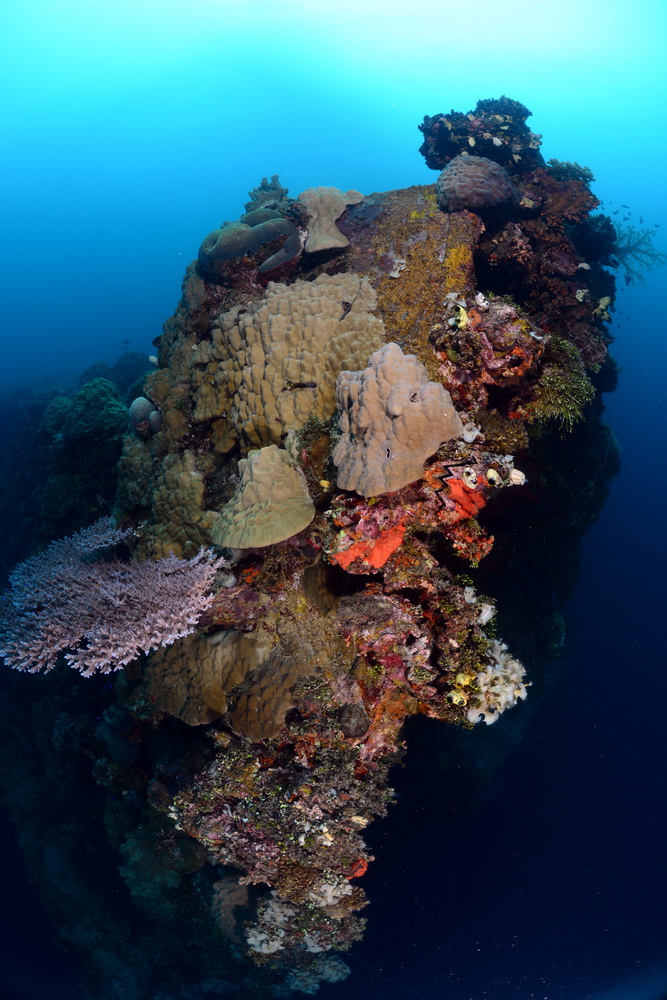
[0,97,614,993]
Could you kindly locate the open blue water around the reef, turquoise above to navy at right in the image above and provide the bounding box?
[0,0,667,1000]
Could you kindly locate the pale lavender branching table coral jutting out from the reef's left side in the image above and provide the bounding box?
[0,518,223,677]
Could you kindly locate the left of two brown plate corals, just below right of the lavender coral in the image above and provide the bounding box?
[140,629,268,726]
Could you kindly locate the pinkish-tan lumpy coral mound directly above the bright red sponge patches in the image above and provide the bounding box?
[333,344,463,497]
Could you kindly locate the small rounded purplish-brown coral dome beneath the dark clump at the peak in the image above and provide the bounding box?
[435,156,518,212]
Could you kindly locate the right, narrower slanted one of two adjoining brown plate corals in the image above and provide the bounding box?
[229,632,314,740]
